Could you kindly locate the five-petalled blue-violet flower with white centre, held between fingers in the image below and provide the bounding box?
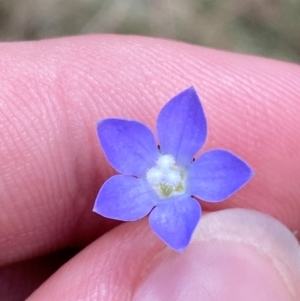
[93,87,253,251]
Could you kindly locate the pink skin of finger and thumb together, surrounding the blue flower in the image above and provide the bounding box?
[0,36,300,301]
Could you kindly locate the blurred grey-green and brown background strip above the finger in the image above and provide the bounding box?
[0,0,300,62]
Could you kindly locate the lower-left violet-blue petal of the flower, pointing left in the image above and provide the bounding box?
[93,175,158,221]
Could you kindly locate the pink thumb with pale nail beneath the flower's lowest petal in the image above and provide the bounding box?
[28,209,300,301]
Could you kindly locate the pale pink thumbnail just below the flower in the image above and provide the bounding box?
[133,209,300,301]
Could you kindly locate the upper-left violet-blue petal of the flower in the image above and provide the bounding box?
[97,118,158,176]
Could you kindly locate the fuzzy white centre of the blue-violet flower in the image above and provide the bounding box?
[146,155,186,198]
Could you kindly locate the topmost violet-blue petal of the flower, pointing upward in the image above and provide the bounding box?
[157,87,207,167]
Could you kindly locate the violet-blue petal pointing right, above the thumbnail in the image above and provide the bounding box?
[188,149,254,202]
